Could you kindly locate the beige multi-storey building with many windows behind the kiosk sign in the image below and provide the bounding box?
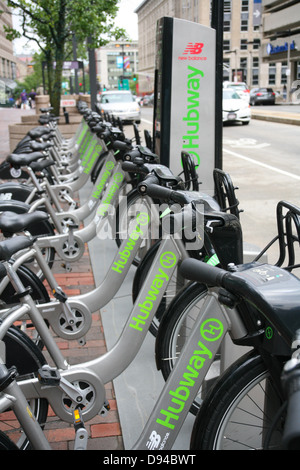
[135,0,300,93]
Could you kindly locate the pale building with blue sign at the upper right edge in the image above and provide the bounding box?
[262,0,300,96]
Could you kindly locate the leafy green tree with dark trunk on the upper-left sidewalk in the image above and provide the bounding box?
[6,0,125,116]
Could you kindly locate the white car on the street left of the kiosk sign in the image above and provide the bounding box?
[99,90,141,123]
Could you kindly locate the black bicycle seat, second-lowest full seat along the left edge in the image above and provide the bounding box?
[0,211,49,237]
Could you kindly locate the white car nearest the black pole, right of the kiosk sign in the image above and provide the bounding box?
[223,88,251,125]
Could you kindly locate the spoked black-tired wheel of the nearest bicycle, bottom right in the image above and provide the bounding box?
[190,351,283,450]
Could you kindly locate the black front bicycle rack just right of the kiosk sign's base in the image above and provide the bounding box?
[213,168,243,219]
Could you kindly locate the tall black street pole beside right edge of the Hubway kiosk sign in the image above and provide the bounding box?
[211,0,224,168]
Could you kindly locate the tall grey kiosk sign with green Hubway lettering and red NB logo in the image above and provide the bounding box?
[154,18,216,194]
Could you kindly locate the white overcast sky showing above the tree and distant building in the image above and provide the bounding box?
[14,0,143,54]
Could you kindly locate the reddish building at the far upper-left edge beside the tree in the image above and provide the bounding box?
[0,0,17,104]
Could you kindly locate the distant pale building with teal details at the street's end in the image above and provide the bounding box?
[96,41,139,93]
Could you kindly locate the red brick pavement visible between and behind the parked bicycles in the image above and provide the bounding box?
[0,109,124,450]
